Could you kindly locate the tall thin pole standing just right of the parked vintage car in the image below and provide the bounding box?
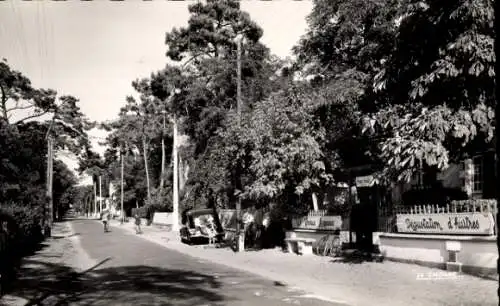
[236,34,245,252]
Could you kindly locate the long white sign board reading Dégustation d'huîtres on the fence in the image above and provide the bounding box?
[396,212,495,235]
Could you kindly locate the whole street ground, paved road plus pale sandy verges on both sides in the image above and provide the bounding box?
[2,220,496,306]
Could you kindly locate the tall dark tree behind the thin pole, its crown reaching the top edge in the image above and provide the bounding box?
[166,0,280,155]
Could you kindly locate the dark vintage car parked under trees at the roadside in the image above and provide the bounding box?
[180,209,224,244]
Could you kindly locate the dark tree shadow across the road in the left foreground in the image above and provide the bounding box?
[13,260,231,305]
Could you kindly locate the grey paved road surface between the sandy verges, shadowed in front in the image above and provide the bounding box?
[51,220,345,306]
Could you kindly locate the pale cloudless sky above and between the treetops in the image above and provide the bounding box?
[0,0,312,182]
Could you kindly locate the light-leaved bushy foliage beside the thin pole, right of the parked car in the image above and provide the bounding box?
[210,86,331,213]
